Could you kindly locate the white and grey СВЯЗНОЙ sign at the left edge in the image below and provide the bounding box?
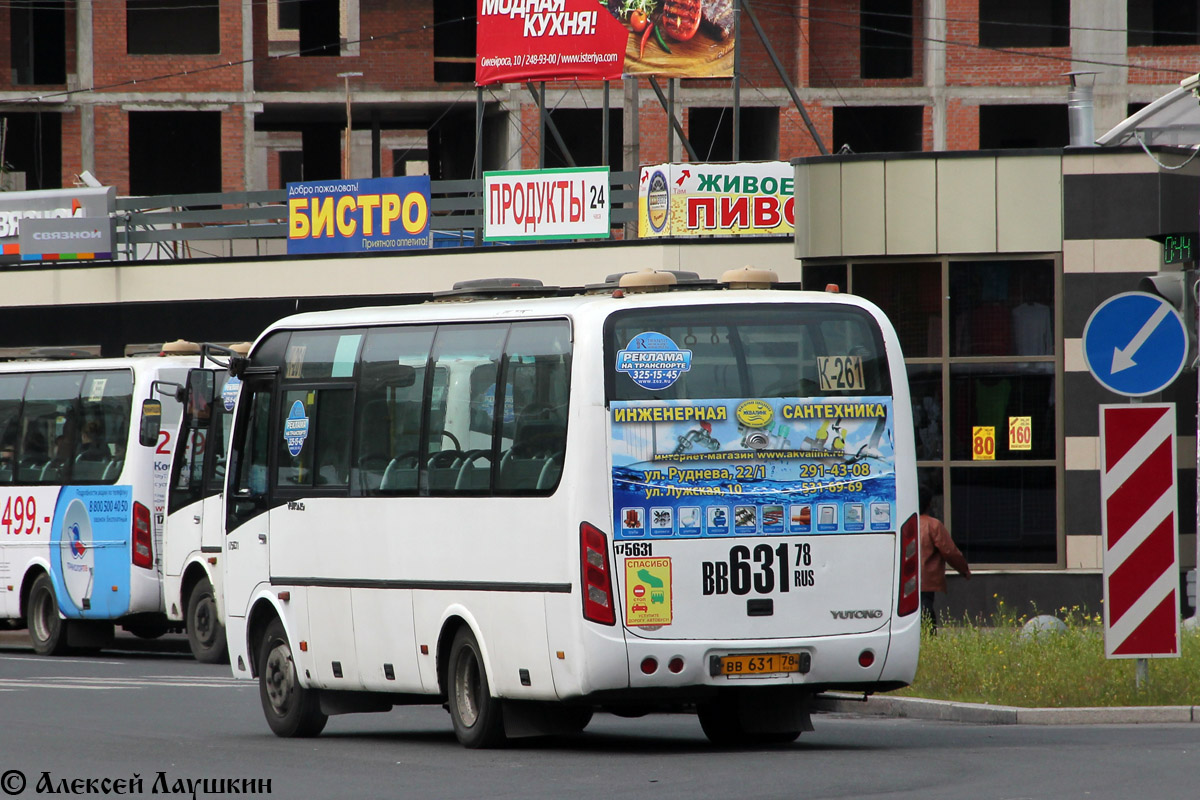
[0,186,116,261]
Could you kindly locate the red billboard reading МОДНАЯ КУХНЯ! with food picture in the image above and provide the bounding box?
[475,0,734,86]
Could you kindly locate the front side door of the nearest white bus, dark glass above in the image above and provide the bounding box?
[224,374,275,616]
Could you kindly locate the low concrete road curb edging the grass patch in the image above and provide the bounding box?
[812,692,1200,724]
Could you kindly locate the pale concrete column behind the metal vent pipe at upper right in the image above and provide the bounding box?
[1063,0,1129,136]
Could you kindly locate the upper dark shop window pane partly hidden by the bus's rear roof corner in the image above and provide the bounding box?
[851,263,942,359]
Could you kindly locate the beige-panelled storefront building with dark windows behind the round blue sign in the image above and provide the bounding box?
[793,148,1200,614]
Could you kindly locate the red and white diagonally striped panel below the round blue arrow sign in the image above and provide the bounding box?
[1100,403,1180,666]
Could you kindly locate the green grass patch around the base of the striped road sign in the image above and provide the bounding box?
[894,600,1200,708]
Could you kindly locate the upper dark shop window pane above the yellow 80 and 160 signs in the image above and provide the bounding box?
[949,260,1055,356]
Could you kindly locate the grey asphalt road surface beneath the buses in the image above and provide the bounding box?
[0,633,1200,800]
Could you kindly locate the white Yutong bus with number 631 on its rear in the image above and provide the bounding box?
[224,271,919,747]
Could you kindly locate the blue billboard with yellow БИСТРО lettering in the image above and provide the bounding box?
[288,175,432,255]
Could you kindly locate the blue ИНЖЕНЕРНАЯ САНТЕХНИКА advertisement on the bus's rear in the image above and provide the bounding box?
[612,397,896,539]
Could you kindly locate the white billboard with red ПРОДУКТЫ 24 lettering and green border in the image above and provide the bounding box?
[484,167,610,241]
